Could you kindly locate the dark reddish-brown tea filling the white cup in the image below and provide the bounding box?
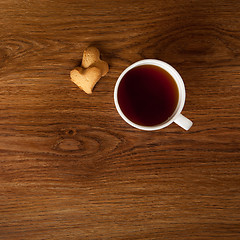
[117,65,179,126]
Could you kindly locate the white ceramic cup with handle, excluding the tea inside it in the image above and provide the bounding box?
[114,59,193,131]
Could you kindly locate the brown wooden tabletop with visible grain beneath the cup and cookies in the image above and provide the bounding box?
[0,0,240,240]
